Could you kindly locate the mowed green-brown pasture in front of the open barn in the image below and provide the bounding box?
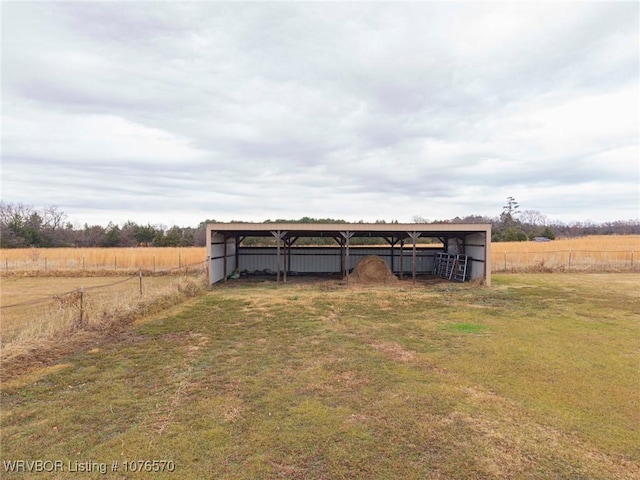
[0,274,640,479]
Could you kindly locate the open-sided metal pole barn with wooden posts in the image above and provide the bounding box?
[207,223,491,285]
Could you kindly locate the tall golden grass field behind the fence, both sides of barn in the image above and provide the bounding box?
[0,235,640,275]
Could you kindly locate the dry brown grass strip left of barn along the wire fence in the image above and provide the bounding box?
[0,276,205,377]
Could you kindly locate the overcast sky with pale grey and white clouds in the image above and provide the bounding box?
[1,2,640,226]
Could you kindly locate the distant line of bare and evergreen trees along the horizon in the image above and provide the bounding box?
[0,201,640,248]
